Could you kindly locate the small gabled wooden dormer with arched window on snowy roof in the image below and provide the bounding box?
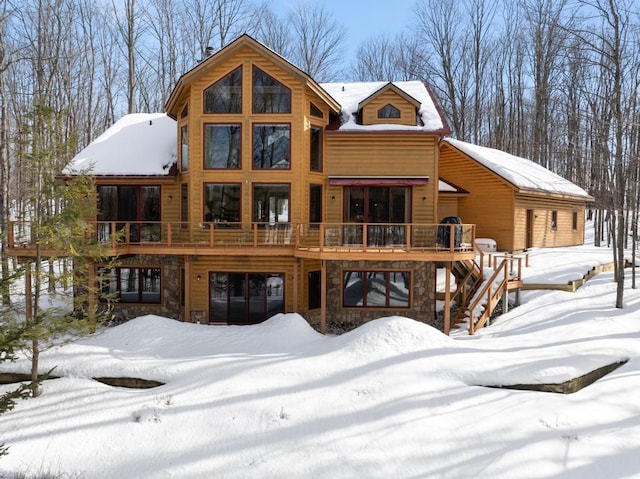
[358,83,421,126]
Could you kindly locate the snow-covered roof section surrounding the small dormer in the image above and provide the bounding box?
[320,81,446,131]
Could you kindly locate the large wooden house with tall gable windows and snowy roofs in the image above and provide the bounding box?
[10,35,590,332]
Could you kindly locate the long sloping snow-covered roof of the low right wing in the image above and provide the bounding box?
[443,138,591,199]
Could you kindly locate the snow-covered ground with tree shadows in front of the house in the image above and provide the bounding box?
[0,230,640,479]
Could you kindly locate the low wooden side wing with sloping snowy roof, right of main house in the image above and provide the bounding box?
[439,138,593,251]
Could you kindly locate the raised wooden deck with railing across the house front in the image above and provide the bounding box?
[7,222,475,261]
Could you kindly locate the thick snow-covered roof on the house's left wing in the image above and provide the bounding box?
[63,113,177,176]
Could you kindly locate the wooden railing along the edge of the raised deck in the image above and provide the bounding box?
[7,221,475,252]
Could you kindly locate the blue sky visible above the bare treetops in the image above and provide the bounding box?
[271,0,415,60]
